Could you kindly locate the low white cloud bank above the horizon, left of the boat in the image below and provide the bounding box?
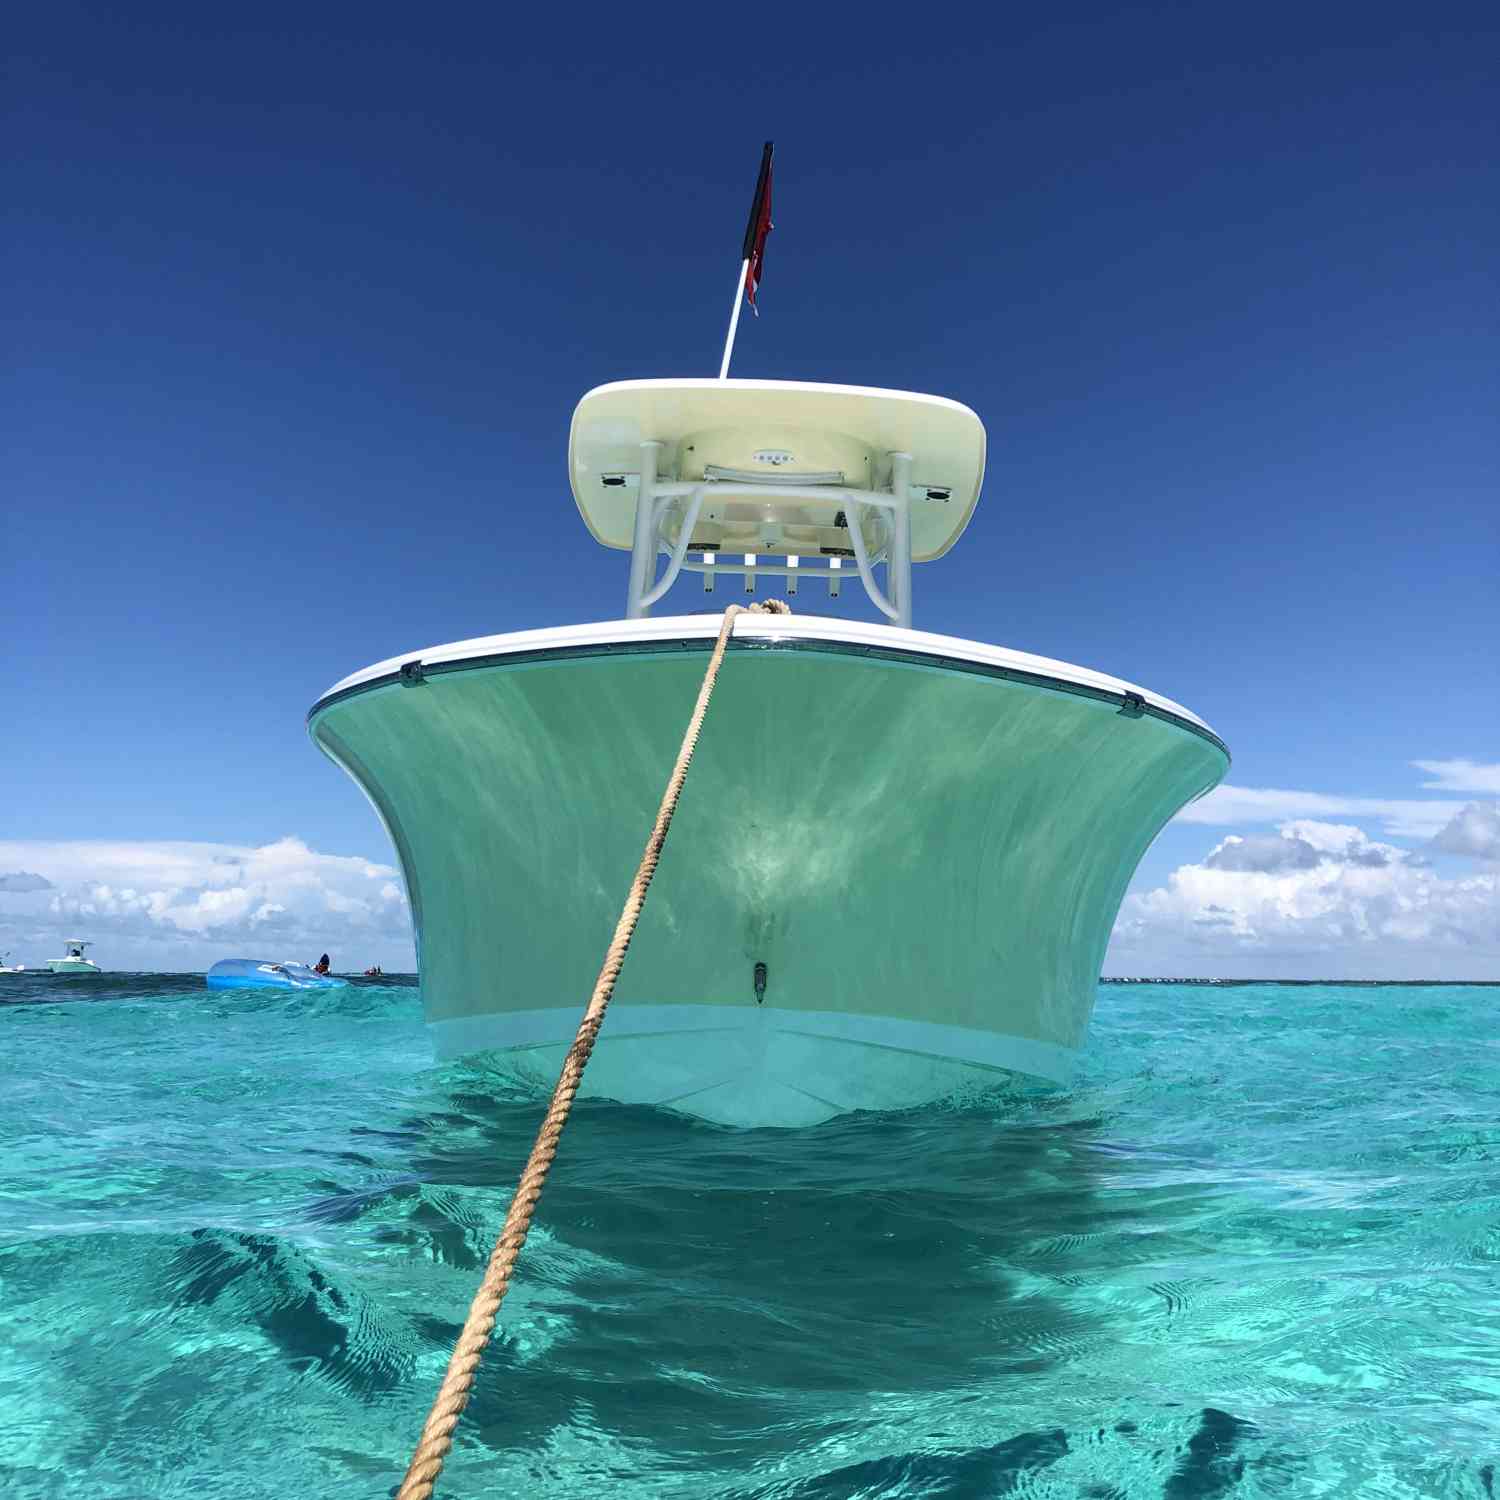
[0,839,413,969]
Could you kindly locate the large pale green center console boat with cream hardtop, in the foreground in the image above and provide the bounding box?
[309,378,1229,1127]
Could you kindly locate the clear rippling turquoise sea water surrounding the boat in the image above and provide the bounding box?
[0,975,1500,1500]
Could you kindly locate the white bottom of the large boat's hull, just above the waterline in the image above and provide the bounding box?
[428,1004,1076,1127]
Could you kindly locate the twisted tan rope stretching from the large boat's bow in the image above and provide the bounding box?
[396,599,792,1500]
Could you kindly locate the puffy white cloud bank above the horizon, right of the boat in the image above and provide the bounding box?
[1109,819,1500,978]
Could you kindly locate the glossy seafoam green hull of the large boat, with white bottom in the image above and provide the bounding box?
[311,621,1229,1125]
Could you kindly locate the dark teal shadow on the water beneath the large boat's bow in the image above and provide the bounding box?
[298,1080,1296,1500]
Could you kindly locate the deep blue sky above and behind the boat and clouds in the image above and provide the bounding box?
[0,5,1500,977]
